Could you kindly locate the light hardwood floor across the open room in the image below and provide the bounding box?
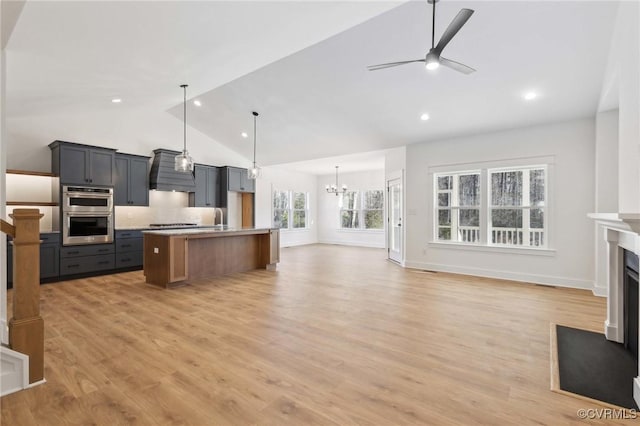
[1,245,636,426]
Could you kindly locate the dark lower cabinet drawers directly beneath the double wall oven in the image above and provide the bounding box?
[60,244,115,276]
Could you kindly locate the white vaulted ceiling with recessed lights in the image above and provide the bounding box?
[7,0,617,174]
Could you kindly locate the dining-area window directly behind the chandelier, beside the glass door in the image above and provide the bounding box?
[340,190,384,229]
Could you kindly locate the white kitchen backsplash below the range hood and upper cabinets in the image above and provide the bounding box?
[115,191,222,229]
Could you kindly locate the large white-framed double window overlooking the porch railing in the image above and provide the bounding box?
[434,166,547,247]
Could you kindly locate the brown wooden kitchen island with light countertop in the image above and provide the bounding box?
[143,227,280,288]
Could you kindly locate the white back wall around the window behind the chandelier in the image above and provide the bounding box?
[317,170,385,248]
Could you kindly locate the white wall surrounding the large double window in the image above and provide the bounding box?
[405,120,595,289]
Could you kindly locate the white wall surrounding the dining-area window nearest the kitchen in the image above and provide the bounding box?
[255,167,318,247]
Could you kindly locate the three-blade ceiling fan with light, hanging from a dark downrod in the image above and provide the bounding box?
[367,0,475,74]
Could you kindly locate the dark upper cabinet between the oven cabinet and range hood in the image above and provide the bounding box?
[113,153,150,206]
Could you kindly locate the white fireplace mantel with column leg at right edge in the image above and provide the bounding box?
[587,213,640,406]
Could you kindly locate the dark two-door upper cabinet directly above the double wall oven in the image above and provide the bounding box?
[49,141,115,186]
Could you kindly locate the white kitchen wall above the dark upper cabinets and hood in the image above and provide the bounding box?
[7,104,251,172]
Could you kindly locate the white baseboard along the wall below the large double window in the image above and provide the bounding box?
[406,261,593,290]
